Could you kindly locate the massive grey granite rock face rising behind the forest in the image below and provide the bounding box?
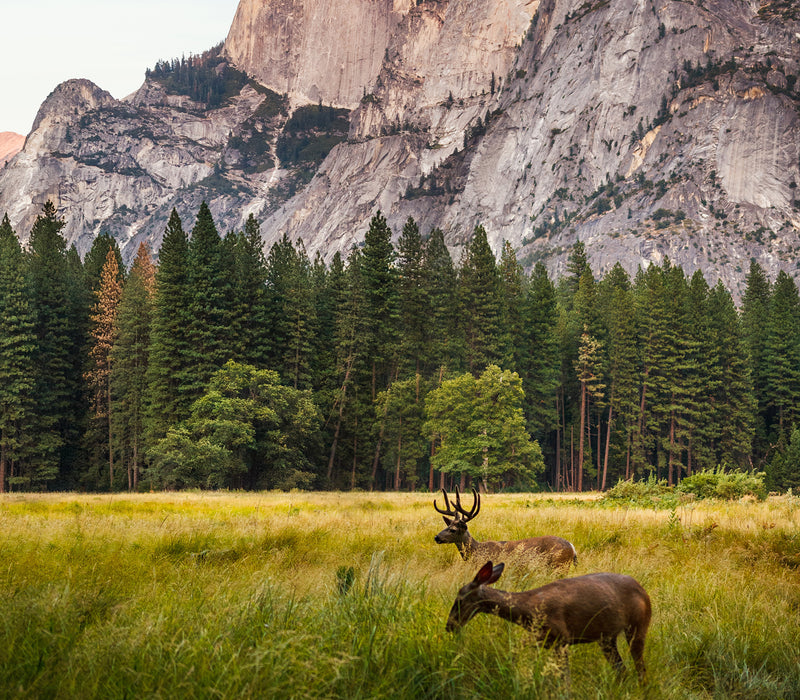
[0,0,800,292]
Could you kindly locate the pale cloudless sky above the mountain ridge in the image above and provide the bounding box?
[0,0,239,135]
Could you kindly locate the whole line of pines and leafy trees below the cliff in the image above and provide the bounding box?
[0,202,800,491]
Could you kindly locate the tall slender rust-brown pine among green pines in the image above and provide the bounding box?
[84,249,122,490]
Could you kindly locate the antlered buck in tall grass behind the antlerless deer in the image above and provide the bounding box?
[433,487,578,570]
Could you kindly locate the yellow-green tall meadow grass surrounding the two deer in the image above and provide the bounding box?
[0,492,800,700]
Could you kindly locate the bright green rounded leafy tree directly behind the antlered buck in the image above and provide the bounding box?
[425,365,544,488]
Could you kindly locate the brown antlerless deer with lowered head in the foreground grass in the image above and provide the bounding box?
[447,561,652,680]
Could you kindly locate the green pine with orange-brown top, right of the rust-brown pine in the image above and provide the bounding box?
[111,243,155,491]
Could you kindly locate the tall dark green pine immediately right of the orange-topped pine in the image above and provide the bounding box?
[145,209,191,443]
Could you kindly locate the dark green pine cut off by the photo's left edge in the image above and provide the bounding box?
[0,215,35,493]
